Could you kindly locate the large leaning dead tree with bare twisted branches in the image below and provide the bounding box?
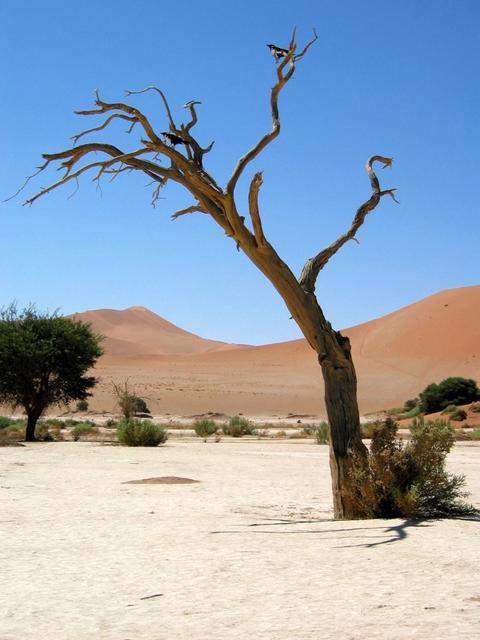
[15,31,394,519]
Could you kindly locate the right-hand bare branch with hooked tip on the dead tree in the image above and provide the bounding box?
[299,156,398,293]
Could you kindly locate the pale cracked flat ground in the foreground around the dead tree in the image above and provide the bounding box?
[0,438,480,640]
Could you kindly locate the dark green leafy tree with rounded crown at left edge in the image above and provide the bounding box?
[0,306,102,441]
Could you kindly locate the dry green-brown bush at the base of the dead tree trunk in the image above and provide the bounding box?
[344,418,477,518]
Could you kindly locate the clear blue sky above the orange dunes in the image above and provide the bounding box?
[0,0,480,344]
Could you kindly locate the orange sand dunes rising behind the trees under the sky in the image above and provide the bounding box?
[71,286,480,417]
